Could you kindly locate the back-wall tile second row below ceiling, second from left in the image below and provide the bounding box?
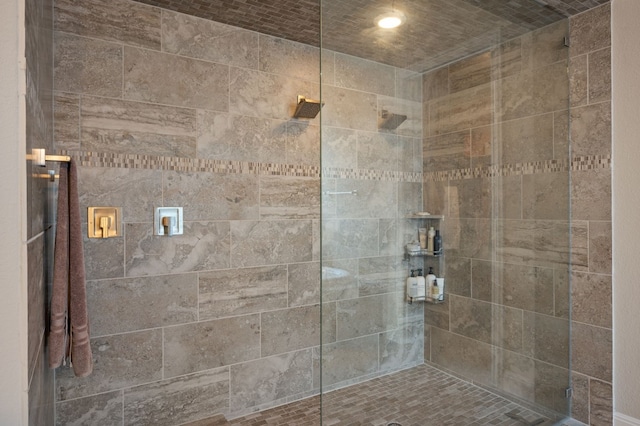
[124,46,229,111]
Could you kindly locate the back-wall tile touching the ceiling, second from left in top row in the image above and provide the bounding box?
[162,10,259,69]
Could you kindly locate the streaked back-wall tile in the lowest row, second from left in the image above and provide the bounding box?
[123,367,229,426]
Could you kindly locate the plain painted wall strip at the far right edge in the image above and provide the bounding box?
[611,0,640,426]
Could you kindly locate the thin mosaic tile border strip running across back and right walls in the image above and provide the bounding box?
[59,151,611,182]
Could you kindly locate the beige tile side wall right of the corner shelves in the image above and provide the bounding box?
[423,5,612,425]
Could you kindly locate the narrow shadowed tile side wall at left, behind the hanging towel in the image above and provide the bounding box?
[26,0,56,425]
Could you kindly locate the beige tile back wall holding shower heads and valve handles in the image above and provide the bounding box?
[54,0,424,425]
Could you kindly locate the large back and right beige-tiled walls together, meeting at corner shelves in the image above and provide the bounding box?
[26,0,611,424]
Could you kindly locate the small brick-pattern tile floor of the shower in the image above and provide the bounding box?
[185,365,581,426]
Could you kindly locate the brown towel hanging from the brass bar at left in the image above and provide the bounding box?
[49,160,93,377]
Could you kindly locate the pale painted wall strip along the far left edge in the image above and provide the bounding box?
[0,0,27,425]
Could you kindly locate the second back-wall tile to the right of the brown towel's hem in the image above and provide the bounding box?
[163,314,260,378]
